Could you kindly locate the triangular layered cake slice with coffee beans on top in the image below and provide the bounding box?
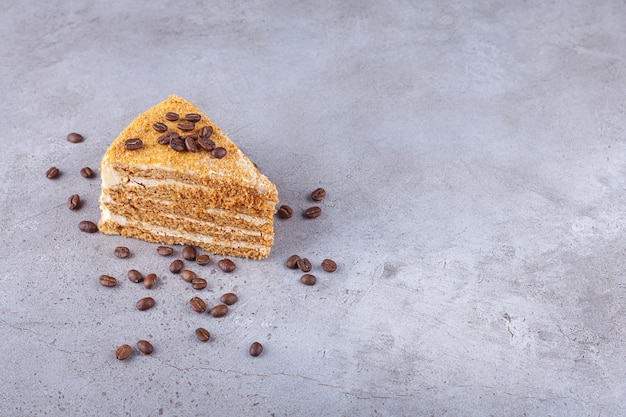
[98,95,278,259]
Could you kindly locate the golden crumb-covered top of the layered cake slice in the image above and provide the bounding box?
[101,95,276,196]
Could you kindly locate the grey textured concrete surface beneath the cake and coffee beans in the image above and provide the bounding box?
[0,0,626,417]
